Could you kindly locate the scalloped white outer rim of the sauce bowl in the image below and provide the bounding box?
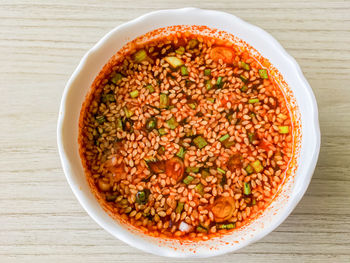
[57,8,321,257]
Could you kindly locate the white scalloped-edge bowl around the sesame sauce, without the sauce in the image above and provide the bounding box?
[57,8,320,257]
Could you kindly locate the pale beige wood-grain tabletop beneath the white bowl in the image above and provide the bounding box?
[0,0,350,263]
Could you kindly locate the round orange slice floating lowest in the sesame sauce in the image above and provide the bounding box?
[211,196,235,222]
